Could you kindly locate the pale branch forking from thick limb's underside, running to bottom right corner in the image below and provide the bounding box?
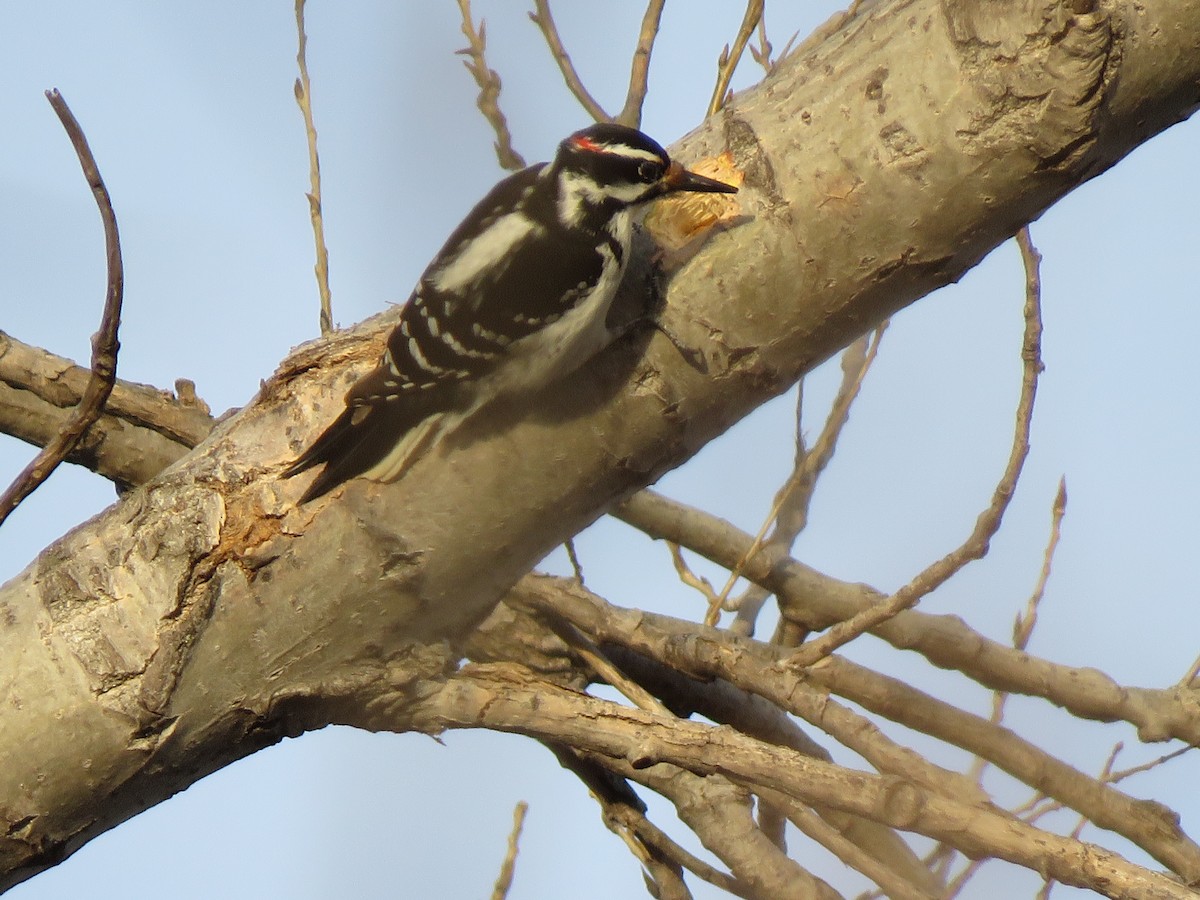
[410,666,1194,900]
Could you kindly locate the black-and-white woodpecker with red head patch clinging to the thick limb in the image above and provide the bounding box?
[283,124,737,503]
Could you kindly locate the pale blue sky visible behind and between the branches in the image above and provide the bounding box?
[0,0,1200,900]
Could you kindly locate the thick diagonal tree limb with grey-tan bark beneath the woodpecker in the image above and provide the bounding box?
[0,0,1200,895]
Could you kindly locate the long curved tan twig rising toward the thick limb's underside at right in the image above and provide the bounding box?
[792,227,1042,667]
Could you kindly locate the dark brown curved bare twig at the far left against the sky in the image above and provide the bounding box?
[0,89,125,524]
